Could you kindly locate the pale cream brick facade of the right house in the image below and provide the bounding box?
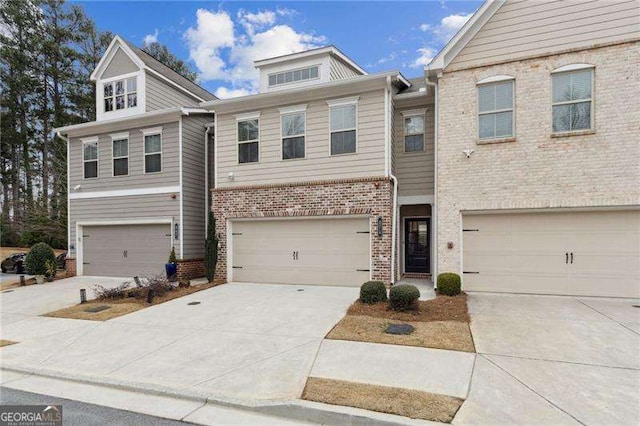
[436,43,640,273]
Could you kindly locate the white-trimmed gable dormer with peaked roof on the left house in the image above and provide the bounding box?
[91,36,217,121]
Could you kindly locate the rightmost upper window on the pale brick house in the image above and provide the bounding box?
[551,68,593,132]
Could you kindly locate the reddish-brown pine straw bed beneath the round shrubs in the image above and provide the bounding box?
[347,293,471,323]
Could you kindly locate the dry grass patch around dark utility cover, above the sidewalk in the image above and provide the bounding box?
[326,315,475,353]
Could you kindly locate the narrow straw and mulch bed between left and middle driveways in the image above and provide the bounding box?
[42,283,218,321]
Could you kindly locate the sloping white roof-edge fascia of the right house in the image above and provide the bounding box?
[425,0,506,72]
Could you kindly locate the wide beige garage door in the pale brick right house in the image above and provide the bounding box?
[463,211,640,297]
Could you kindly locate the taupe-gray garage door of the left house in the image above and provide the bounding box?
[82,224,171,277]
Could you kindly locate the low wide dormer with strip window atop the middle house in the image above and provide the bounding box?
[254,46,367,93]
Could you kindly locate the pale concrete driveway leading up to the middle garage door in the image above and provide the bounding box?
[0,284,358,401]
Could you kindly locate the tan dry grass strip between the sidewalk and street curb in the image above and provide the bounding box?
[302,377,464,423]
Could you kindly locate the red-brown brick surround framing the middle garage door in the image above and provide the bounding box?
[212,177,393,283]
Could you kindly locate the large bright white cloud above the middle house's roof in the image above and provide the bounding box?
[185,9,326,92]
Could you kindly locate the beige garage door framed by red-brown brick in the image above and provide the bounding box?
[232,218,370,286]
